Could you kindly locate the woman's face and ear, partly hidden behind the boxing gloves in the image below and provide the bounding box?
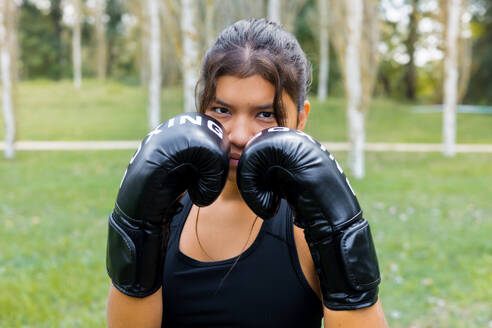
[205,75,309,181]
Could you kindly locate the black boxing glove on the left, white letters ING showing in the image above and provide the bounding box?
[106,113,230,297]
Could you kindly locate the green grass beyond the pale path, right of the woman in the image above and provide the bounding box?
[306,96,492,143]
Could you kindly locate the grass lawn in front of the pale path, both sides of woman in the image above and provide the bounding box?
[0,151,492,327]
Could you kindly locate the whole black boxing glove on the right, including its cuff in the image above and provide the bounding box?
[237,127,380,310]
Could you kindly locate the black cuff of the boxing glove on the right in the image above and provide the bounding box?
[304,219,381,310]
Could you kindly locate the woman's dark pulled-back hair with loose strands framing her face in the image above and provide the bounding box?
[197,18,311,125]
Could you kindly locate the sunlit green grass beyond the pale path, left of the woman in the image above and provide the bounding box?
[4,80,183,140]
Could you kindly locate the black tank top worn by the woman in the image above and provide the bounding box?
[162,195,323,328]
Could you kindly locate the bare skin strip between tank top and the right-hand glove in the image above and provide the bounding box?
[293,225,321,300]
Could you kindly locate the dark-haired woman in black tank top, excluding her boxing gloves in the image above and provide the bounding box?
[108,19,386,327]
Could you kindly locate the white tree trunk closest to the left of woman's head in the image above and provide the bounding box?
[181,0,200,112]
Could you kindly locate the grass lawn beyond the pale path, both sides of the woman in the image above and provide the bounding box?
[0,80,492,143]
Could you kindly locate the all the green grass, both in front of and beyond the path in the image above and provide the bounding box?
[0,80,492,327]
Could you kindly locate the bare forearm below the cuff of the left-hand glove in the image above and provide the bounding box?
[107,284,162,328]
